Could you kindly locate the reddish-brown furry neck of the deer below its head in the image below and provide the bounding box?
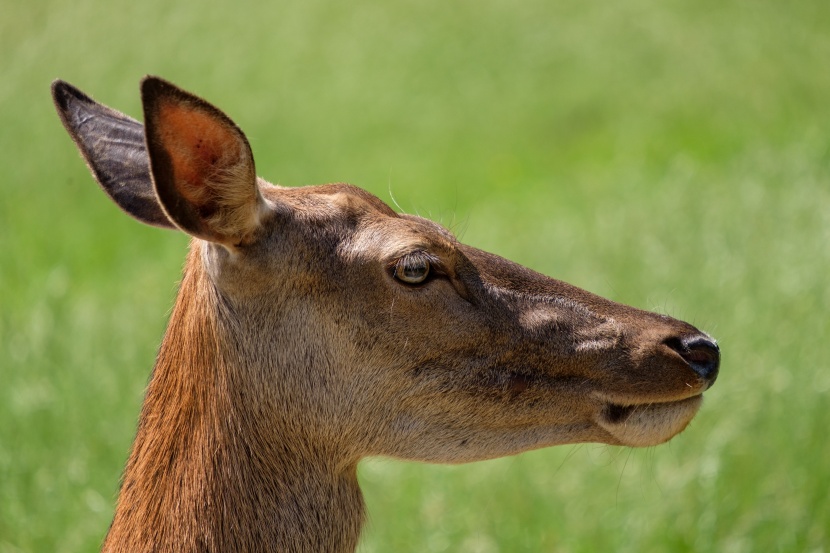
[103,248,363,552]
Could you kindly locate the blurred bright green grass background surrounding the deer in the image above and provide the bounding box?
[0,0,830,553]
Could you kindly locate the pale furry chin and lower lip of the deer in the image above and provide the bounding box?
[597,394,703,447]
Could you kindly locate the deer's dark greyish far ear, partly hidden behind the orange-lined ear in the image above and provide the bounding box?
[52,80,175,228]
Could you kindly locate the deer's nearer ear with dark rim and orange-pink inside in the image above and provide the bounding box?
[141,77,266,246]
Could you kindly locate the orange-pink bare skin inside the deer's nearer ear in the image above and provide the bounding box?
[156,102,239,205]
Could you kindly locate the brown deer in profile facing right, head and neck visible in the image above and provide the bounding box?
[52,76,720,553]
